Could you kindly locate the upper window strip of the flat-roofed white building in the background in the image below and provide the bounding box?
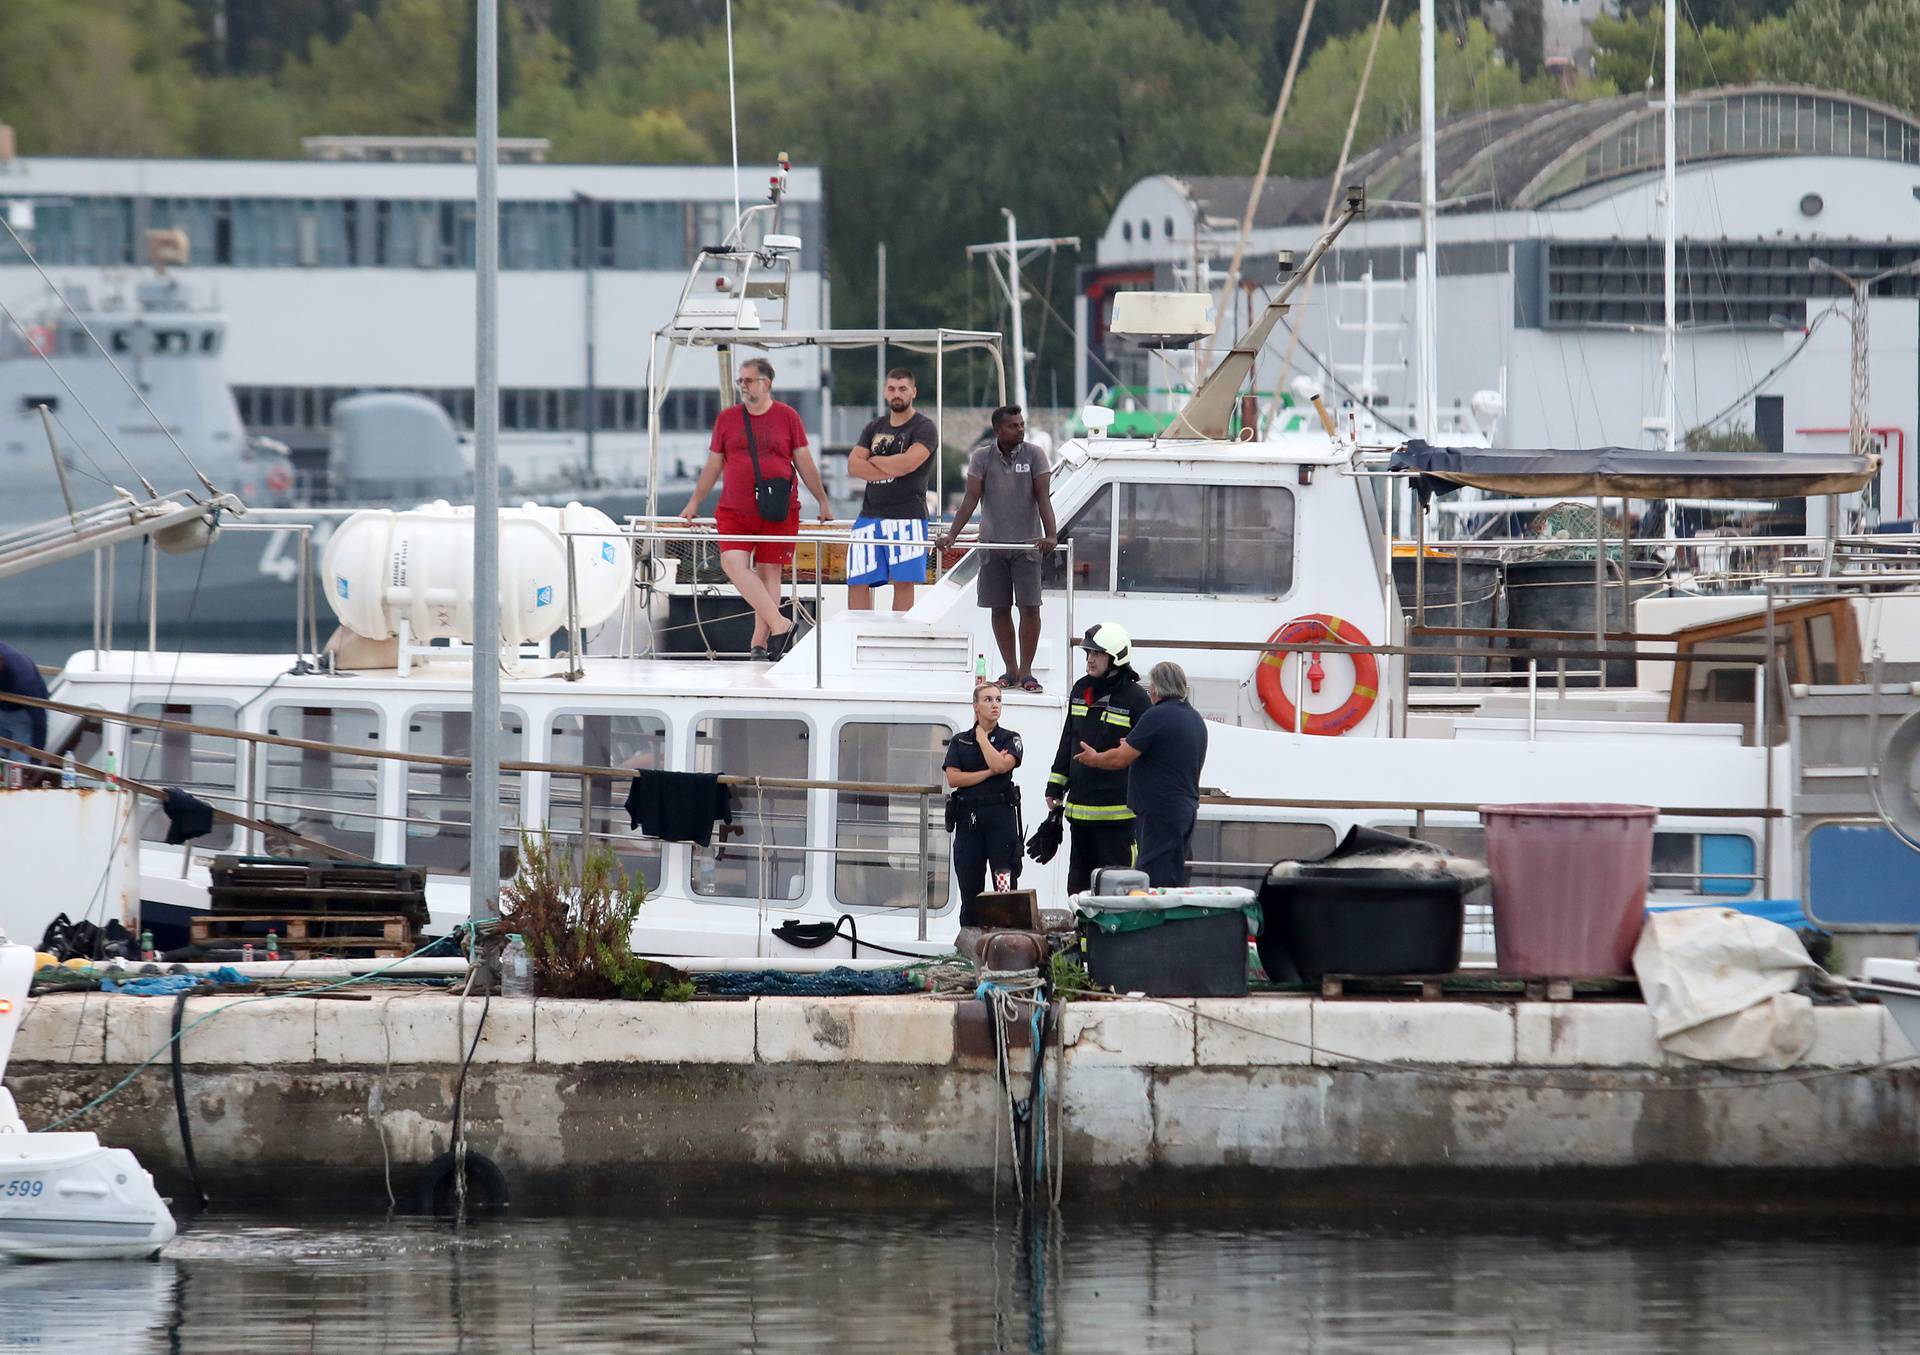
[0,196,822,271]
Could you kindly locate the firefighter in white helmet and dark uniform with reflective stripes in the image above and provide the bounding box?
[1046,622,1154,894]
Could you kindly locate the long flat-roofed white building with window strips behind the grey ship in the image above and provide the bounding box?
[0,138,829,482]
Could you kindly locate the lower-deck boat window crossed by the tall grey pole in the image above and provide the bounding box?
[401,706,526,877]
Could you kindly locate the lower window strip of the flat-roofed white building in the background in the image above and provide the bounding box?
[232,386,794,434]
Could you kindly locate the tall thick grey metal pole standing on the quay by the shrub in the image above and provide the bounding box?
[467,0,499,923]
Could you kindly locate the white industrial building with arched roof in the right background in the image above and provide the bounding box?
[1079,86,1920,520]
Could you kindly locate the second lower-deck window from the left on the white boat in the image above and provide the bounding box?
[255,704,380,858]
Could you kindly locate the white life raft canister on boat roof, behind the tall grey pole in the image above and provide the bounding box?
[323,501,599,645]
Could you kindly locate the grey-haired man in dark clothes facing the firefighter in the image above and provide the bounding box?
[1073,662,1206,889]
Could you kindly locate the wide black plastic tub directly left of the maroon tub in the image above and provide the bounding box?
[1260,866,1473,983]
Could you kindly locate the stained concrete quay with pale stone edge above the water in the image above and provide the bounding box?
[6,992,1920,1205]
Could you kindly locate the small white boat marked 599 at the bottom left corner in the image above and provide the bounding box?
[0,944,173,1261]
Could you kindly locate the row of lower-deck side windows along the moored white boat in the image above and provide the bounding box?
[75,702,1757,908]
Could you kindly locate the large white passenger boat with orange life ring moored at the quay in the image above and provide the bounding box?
[30,182,1920,958]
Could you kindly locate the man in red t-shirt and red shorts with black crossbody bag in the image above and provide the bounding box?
[680,357,833,658]
